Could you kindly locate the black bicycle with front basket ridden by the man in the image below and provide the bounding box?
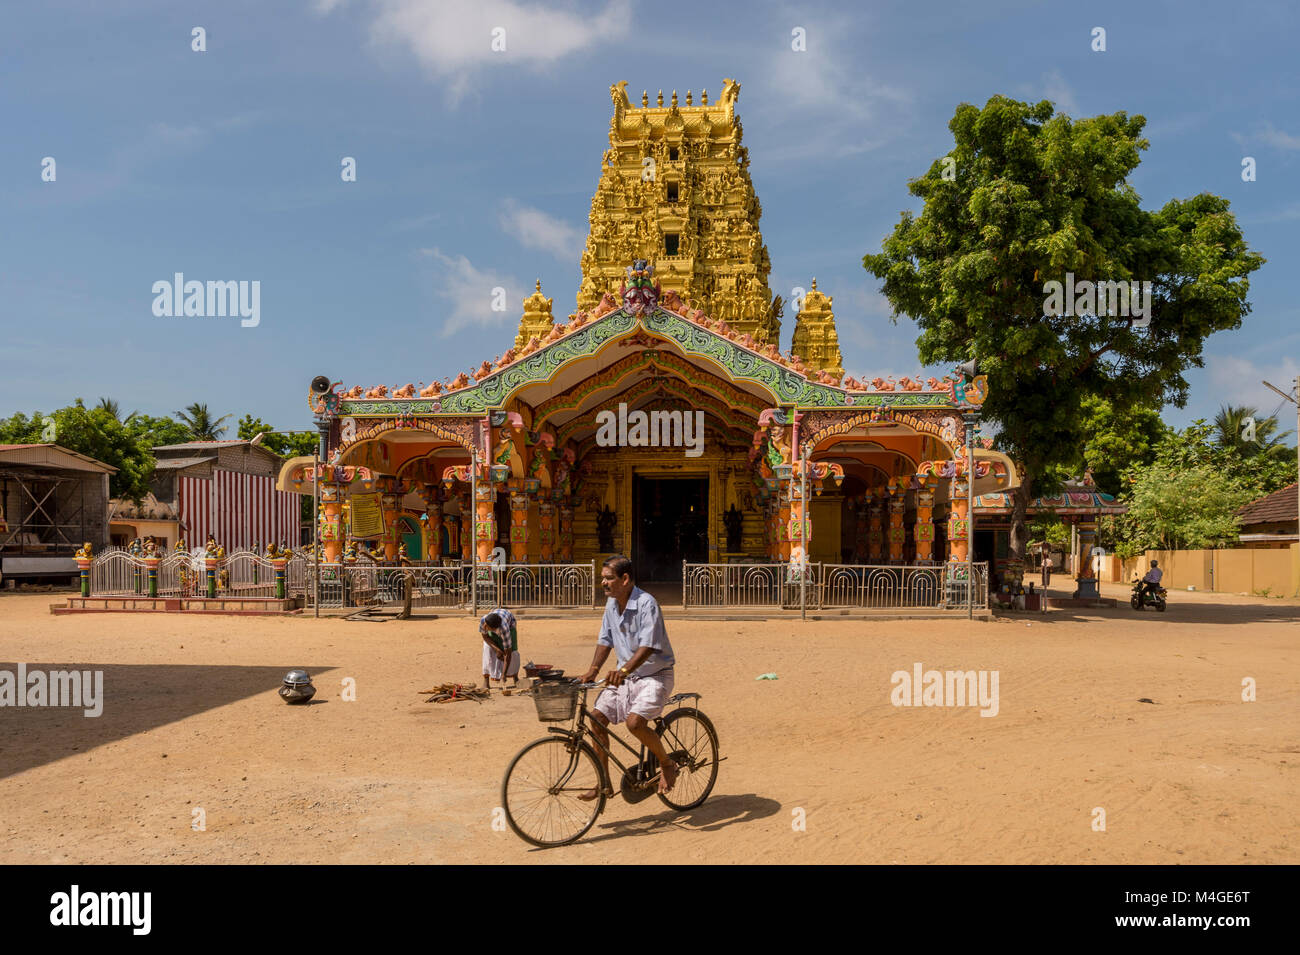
[501,677,720,847]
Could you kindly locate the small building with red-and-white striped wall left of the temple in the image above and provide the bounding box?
[113,440,303,551]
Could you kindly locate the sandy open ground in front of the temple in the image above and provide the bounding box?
[0,587,1300,864]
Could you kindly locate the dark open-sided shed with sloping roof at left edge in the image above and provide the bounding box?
[0,444,117,577]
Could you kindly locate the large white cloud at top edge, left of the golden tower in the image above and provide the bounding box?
[325,0,634,103]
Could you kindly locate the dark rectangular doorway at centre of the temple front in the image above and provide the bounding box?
[631,476,709,587]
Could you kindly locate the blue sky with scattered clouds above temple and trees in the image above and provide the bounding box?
[0,0,1300,434]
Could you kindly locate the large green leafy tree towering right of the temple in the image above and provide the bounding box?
[863,96,1264,557]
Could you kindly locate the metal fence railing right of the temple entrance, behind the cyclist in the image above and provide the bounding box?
[681,563,988,611]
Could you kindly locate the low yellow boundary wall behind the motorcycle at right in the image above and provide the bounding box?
[1097,544,1300,596]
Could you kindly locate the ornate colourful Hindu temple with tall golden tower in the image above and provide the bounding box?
[280,79,1015,605]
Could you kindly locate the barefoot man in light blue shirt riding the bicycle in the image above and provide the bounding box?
[580,554,677,799]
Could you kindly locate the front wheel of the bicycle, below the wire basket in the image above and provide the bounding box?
[501,737,605,847]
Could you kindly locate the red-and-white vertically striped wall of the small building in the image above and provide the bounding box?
[177,468,302,551]
